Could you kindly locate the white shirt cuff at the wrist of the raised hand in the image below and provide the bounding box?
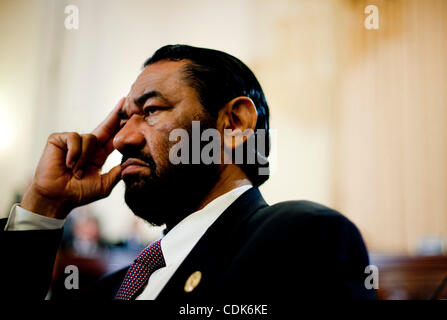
[5,203,65,231]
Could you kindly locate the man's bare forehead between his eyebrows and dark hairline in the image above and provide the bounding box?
[128,60,187,100]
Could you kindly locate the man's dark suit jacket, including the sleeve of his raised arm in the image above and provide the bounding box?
[0,188,375,302]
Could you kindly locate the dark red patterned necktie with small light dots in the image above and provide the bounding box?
[115,239,166,300]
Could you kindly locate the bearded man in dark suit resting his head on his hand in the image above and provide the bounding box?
[0,45,375,301]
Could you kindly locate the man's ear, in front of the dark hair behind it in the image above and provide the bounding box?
[217,96,258,150]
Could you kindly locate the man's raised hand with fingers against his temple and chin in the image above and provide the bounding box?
[20,98,125,219]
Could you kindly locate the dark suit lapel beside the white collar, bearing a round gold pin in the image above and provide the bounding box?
[157,188,267,300]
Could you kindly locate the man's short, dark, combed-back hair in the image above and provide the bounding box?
[144,44,270,186]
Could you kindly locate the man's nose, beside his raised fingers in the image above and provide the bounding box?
[113,115,145,153]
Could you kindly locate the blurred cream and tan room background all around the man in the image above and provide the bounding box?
[0,0,447,299]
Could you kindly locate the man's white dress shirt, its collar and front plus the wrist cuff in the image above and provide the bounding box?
[5,185,252,300]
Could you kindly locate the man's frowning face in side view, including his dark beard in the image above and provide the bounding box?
[113,61,217,227]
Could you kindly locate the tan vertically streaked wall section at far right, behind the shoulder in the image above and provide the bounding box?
[333,0,447,252]
